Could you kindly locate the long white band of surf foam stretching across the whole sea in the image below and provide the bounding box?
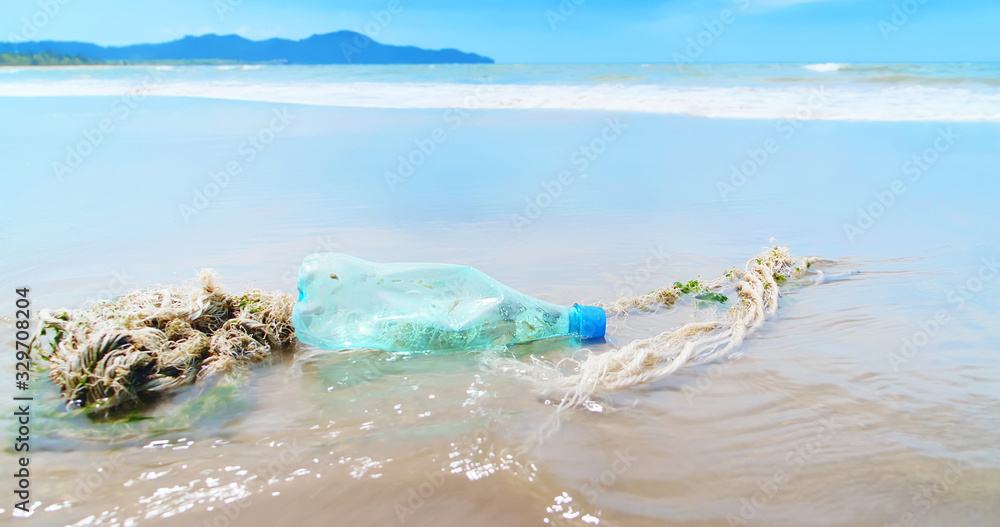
[0,78,1000,122]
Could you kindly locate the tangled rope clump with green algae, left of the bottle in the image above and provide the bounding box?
[35,270,296,412]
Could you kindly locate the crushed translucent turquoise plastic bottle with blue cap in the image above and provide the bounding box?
[292,253,607,352]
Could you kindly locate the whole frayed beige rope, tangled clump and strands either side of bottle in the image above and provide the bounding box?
[32,247,815,411]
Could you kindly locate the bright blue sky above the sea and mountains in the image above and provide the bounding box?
[0,0,1000,63]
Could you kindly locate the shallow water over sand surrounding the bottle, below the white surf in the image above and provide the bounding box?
[0,67,1000,526]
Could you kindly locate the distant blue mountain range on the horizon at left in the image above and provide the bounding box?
[0,31,493,64]
